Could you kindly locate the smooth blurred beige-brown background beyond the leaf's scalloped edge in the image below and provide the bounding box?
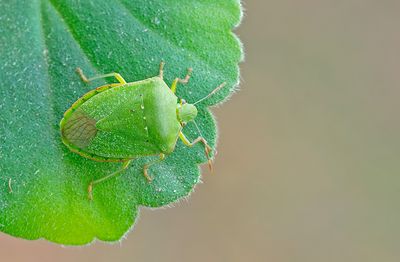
[0,0,400,262]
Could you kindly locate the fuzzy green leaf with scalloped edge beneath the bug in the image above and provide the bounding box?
[0,0,242,245]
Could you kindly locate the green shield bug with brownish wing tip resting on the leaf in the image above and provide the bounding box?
[60,62,225,199]
